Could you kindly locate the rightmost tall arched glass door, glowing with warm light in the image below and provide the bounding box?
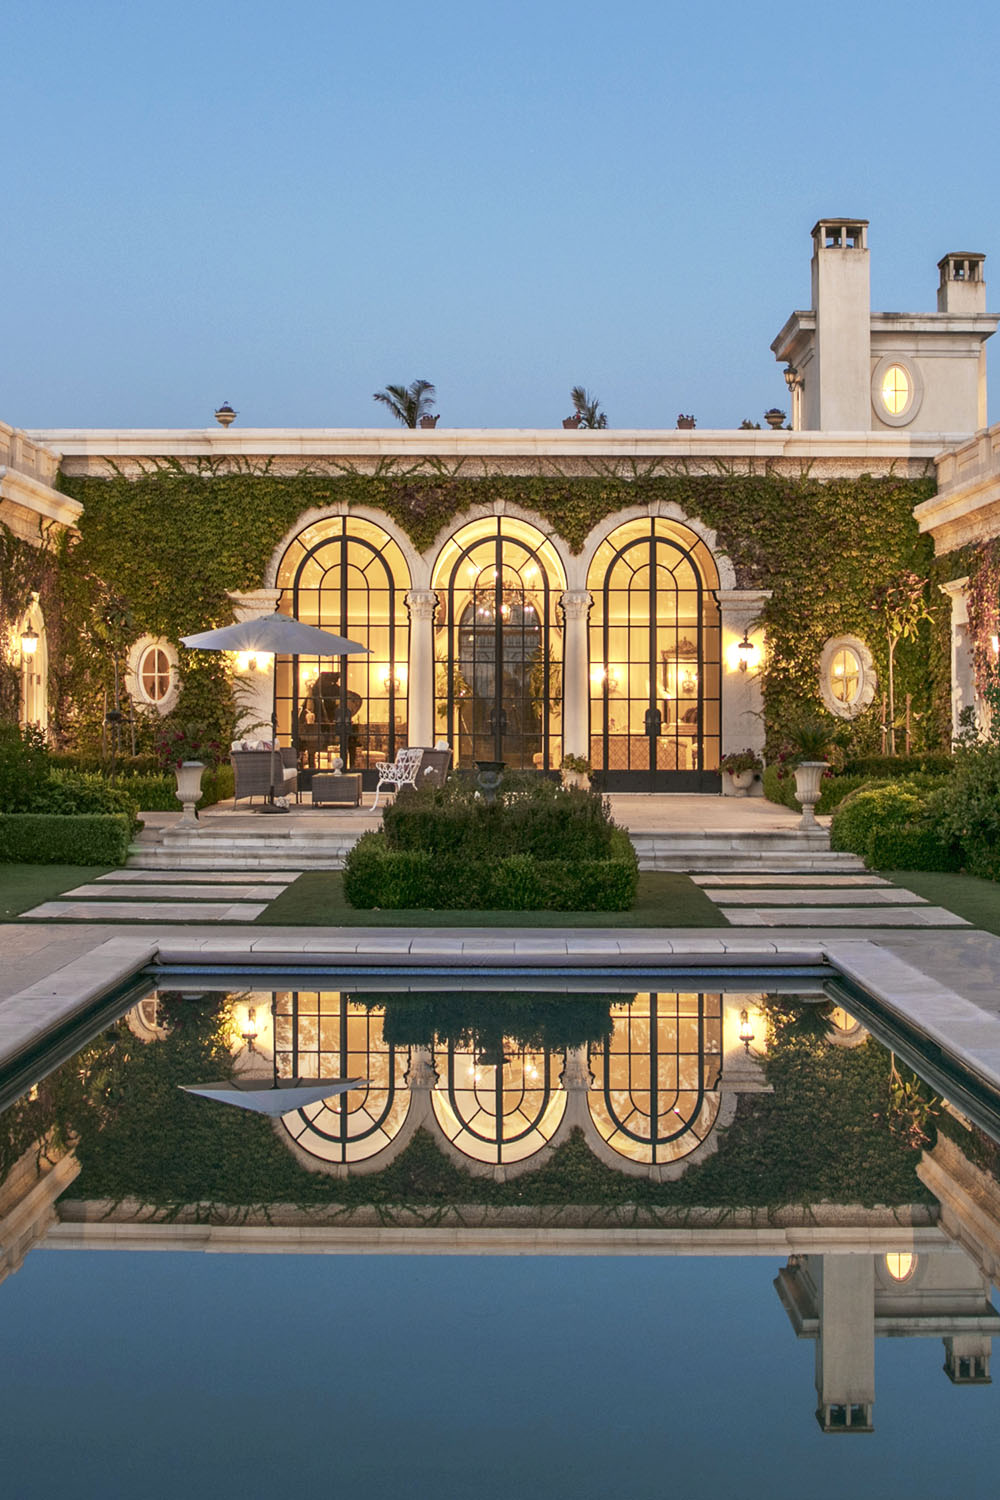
[588,518,721,792]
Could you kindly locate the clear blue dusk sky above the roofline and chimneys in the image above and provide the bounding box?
[0,0,1000,428]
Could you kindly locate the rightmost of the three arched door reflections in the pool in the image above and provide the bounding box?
[588,995,723,1163]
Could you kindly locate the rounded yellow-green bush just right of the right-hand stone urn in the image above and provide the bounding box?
[831,782,960,870]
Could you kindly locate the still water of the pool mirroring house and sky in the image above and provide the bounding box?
[0,975,1000,1500]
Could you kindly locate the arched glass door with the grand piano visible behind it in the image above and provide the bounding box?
[276,516,409,786]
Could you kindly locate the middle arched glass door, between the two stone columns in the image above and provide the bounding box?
[435,516,565,771]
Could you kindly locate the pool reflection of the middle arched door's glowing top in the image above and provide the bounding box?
[432,1040,567,1166]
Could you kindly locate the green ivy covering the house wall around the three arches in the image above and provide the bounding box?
[1,464,949,750]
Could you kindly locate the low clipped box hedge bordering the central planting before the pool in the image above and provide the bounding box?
[343,828,639,912]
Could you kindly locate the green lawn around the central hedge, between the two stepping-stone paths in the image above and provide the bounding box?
[256,870,729,927]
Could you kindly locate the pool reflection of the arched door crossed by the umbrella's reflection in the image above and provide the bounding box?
[274,990,409,1163]
